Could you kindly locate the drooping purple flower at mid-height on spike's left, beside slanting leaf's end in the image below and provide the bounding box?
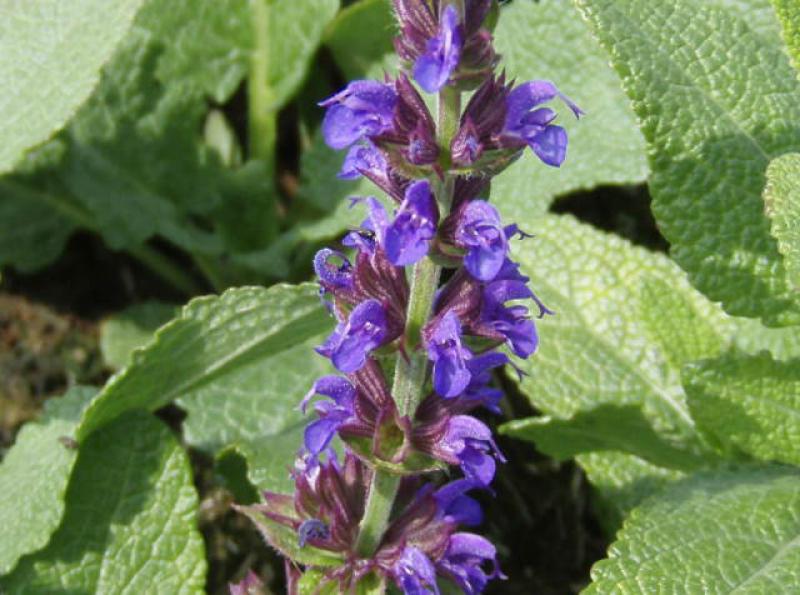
[317,300,388,374]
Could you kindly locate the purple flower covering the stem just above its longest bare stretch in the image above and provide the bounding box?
[384,180,439,266]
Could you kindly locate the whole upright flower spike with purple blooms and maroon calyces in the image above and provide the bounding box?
[234,0,581,595]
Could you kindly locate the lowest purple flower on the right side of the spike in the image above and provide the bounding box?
[436,533,505,595]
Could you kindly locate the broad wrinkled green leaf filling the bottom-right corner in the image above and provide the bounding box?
[584,467,800,595]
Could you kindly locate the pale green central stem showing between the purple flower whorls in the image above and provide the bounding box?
[356,0,463,557]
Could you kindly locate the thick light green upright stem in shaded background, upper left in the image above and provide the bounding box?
[247,0,278,241]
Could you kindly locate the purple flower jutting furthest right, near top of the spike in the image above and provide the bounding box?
[504,81,583,167]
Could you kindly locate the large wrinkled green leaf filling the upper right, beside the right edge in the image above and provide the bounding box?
[578,0,800,325]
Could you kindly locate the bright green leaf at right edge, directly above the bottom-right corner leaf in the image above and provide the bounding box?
[683,353,800,465]
